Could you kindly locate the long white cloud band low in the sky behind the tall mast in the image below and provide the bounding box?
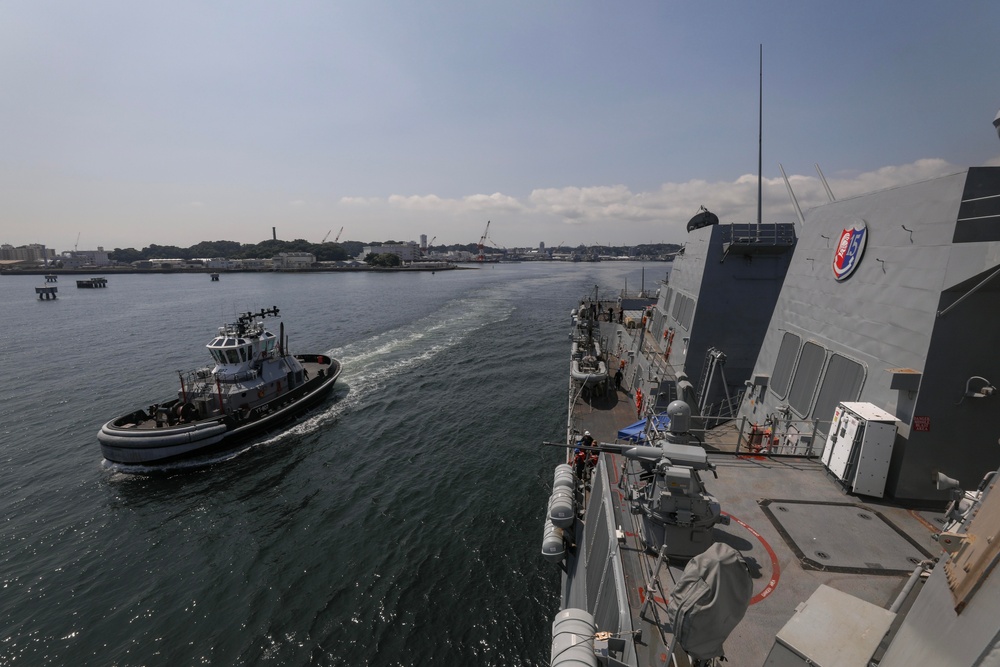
[326,159,959,243]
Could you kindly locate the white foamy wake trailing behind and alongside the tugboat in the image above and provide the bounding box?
[102,296,514,475]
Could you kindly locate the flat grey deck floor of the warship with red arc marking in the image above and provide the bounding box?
[563,322,941,666]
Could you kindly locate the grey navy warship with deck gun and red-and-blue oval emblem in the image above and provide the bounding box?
[542,115,1000,667]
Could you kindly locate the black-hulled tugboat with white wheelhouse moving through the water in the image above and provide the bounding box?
[97,307,341,464]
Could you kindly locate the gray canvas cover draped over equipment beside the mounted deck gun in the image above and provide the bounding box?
[667,542,753,660]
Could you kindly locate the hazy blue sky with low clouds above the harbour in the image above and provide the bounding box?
[0,0,1000,252]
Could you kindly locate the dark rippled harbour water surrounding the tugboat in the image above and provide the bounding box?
[0,263,666,667]
